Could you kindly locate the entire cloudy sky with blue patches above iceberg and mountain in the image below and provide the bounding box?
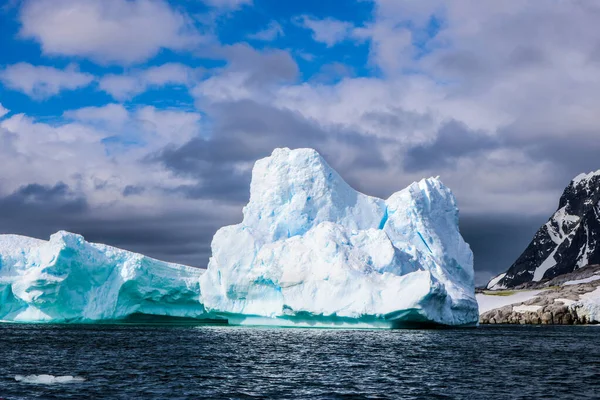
[0,0,600,284]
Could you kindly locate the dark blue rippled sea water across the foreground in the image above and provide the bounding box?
[0,325,600,399]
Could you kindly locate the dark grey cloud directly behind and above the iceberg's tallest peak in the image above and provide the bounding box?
[149,100,387,203]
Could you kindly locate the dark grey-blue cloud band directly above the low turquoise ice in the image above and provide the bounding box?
[0,183,234,267]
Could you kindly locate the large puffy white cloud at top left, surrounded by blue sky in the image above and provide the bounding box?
[19,0,203,65]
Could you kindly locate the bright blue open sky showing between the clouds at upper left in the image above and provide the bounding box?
[0,1,377,117]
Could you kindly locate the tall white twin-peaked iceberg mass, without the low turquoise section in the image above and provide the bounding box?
[200,148,478,327]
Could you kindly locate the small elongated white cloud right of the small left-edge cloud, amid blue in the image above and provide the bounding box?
[99,63,201,100]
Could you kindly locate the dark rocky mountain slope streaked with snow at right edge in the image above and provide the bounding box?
[488,171,600,289]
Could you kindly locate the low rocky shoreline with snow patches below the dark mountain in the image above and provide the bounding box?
[478,265,600,325]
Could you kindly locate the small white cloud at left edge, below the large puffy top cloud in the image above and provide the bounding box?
[0,62,95,100]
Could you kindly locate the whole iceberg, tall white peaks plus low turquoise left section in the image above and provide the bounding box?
[0,148,478,328]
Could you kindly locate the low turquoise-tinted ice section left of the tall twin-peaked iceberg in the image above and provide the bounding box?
[0,231,205,322]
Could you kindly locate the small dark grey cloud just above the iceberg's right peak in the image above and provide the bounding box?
[404,120,500,172]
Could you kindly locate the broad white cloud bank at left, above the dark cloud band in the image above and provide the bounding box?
[0,104,202,216]
